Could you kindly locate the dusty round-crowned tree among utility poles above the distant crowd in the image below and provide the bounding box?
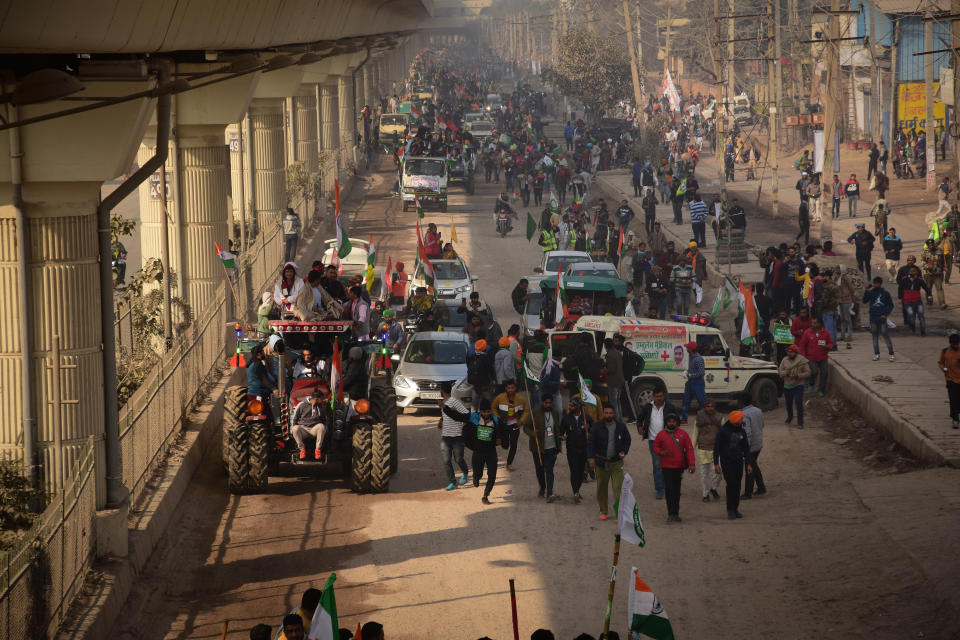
[548,29,644,119]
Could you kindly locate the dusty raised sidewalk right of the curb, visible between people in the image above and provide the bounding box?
[595,162,960,466]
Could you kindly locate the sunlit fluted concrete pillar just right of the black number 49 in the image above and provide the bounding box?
[250,98,287,233]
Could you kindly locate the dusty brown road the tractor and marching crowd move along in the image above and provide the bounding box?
[113,155,960,640]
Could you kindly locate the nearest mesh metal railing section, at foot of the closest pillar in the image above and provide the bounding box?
[0,436,97,638]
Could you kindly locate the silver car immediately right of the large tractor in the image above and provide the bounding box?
[393,331,473,411]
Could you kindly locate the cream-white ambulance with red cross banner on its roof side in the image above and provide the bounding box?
[549,316,783,411]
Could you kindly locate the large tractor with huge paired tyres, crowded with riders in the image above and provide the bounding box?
[223,320,399,494]
